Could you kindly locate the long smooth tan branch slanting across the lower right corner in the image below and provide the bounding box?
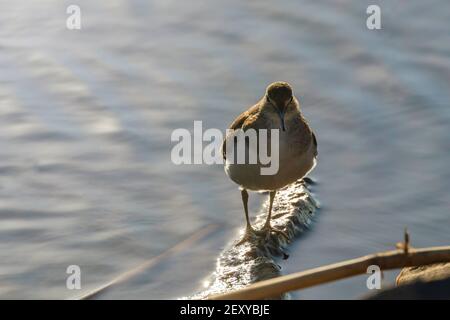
[208,245,450,300]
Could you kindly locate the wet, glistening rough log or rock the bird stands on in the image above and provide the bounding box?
[183,178,319,299]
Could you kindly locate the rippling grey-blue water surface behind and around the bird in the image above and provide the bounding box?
[0,0,450,299]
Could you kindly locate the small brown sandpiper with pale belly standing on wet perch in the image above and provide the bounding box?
[222,82,317,244]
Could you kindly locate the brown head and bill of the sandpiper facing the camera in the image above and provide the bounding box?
[266,81,294,131]
